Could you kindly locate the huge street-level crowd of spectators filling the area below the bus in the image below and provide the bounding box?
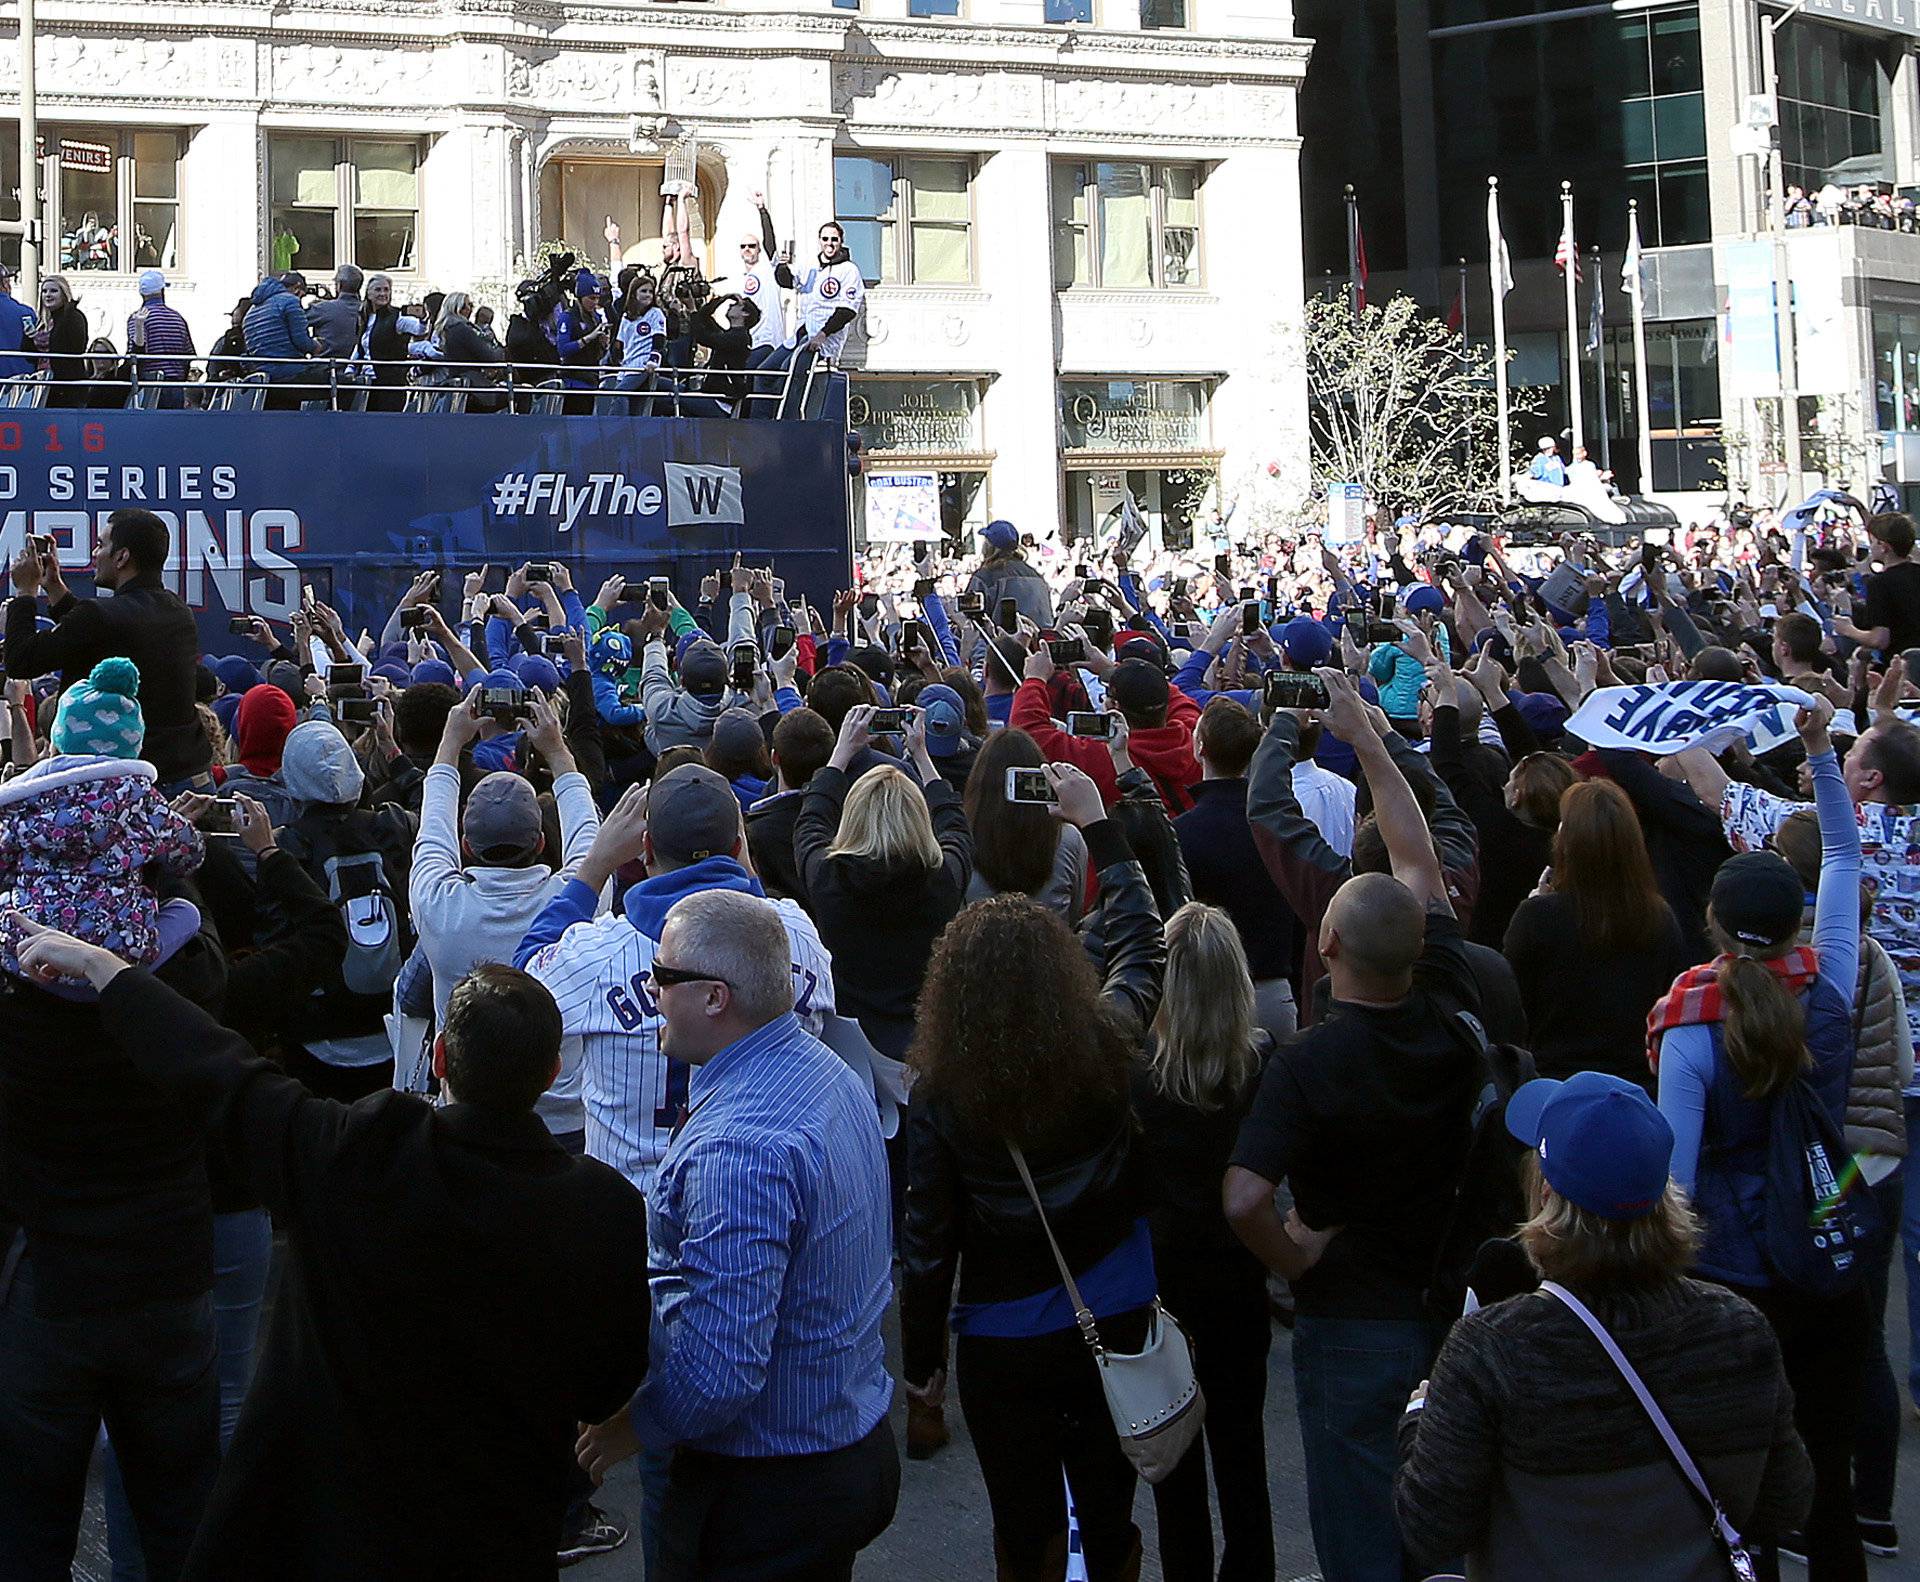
[0,491,1920,1582]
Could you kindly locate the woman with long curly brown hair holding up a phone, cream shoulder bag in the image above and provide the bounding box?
[900,764,1165,1582]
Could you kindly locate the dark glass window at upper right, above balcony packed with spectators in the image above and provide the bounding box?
[1778,17,1893,192]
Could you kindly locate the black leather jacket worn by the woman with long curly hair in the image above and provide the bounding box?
[900,818,1165,1384]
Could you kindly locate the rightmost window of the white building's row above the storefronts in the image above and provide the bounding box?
[1052,159,1200,290]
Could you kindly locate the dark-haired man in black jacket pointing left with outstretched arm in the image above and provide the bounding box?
[0,923,651,1576]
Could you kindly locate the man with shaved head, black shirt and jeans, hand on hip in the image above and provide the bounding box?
[1223,670,1484,1582]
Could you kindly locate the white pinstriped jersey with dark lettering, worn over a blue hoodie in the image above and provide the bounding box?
[526,900,833,1192]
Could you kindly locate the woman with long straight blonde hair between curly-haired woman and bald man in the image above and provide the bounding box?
[1133,900,1273,1582]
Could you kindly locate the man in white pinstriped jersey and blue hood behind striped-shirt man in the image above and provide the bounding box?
[513,764,833,1192]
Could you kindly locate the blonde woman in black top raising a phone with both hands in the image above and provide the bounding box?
[793,705,973,1060]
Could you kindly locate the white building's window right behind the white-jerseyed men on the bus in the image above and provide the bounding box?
[833,154,973,286]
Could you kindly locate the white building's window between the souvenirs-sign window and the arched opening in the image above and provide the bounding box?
[267,134,420,273]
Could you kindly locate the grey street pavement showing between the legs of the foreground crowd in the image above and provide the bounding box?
[73,1259,1920,1582]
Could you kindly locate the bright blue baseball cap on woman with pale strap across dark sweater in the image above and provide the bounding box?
[1507,1071,1674,1219]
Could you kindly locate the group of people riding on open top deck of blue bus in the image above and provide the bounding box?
[0,194,866,417]
